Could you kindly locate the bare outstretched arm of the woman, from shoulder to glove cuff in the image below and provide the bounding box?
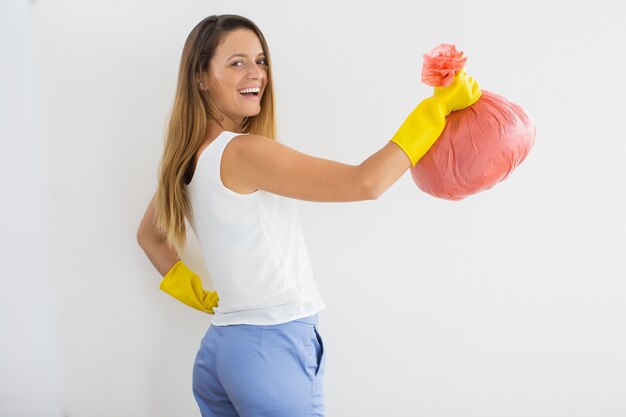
[229,135,411,202]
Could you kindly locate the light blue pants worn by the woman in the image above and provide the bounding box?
[193,314,326,417]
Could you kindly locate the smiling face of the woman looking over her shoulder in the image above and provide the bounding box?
[205,28,267,131]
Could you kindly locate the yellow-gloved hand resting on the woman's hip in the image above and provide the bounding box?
[159,260,219,314]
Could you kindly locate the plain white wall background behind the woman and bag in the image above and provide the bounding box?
[0,0,626,417]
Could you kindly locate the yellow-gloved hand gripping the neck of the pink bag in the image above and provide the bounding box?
[390,68,480,166]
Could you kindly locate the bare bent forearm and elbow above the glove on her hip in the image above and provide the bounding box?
[137,193,180,276]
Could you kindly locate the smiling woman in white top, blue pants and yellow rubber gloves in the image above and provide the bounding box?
[137,15,480,417]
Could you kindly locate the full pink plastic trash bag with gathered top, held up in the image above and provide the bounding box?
[411,44,535,200]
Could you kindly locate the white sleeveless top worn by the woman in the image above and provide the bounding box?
[186,131,326,326]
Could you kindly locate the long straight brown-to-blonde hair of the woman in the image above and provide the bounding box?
[155,14,277,251]
